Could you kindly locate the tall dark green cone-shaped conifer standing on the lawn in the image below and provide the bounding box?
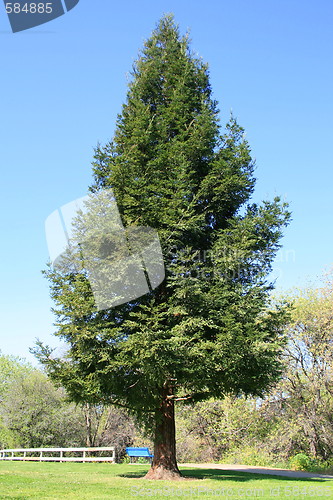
[33,16,289,478]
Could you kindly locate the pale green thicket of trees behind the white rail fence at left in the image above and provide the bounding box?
[0,354,141,460]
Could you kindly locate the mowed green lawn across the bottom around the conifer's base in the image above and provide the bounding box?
[0,462,333,500]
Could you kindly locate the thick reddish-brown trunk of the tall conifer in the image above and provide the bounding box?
[145,387,182,479]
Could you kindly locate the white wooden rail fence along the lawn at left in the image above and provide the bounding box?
[0,446,115,463]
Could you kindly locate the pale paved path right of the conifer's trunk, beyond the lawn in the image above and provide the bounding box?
[179,464,333,479]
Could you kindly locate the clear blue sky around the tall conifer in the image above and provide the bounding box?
[0,0,333,366]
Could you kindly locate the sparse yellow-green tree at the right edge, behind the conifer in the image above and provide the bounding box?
[262,276,333,460]
